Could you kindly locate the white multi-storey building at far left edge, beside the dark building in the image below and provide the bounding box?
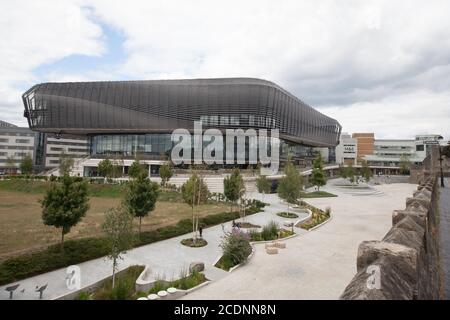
[0,121,36,174]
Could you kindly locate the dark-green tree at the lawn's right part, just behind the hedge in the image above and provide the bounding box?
[123,173,159,235]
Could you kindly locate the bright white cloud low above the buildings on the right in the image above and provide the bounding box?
[319,90,450,139]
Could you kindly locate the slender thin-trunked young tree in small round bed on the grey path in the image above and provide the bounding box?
[181,172,209,243]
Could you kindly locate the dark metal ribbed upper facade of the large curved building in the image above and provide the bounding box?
[23,78,341,147]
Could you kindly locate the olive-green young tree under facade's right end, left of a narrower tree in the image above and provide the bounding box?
[277,162,303,212]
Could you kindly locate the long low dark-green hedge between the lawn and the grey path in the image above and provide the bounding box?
[0,201,264,285]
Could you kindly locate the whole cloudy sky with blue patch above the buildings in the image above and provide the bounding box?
[0,0,450,139]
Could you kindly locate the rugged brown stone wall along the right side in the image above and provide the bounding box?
[341,176,440,300]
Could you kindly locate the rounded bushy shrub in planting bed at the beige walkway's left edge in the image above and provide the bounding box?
[220,230,252,269]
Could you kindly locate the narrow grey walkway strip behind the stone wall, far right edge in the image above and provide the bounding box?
[439,179,450,299]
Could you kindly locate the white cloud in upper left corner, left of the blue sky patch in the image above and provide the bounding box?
[0,0,104,124]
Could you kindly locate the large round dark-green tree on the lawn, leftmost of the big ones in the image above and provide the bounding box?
[41,175,89,247]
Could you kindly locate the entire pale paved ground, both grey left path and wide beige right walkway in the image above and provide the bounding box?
[0,184,416,299]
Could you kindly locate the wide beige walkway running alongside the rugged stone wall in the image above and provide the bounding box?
[183,184,417,300]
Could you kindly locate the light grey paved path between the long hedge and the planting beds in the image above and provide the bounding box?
[0,195,307,300]
